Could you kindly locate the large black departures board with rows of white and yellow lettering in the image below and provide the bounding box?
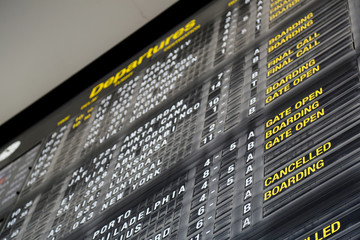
[0,0,360,240]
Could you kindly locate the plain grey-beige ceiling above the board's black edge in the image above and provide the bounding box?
[0,0,177,125]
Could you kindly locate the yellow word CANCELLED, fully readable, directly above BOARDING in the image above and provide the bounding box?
[264,142,331,187]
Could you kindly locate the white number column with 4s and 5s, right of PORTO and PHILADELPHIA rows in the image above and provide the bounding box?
[187,141,237,240]
